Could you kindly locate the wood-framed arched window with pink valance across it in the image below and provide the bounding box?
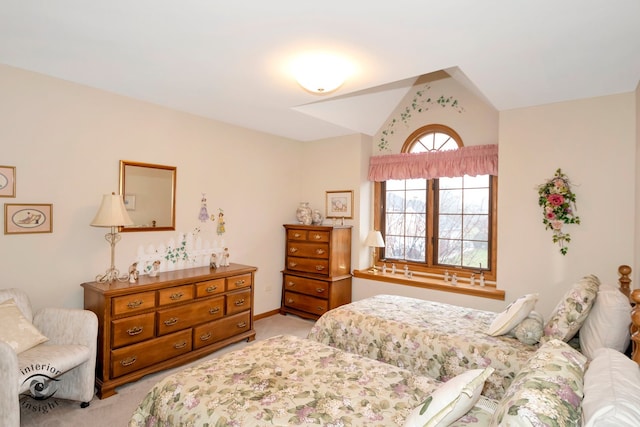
[374,124,497,280]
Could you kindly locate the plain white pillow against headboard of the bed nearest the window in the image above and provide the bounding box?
[579,286,631,359]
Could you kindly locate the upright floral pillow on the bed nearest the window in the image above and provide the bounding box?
[540,275,600,342]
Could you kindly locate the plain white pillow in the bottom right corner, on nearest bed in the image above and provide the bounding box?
[582,347,640,427]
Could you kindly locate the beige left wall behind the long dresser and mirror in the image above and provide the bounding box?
[0,66,306,313]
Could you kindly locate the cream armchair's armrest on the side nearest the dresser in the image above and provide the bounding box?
[33,308,98,348]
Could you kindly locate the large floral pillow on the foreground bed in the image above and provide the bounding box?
[490,339,587,427]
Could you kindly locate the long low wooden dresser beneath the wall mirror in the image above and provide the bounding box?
[82,264,257,399]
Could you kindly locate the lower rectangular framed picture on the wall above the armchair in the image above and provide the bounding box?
[4,203,53,234]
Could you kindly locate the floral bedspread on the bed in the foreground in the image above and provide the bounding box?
[129,336,444,427]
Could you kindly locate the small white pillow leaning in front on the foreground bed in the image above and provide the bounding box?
[404,367,494,427]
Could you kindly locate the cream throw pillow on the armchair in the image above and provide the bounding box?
[0,298,48,353]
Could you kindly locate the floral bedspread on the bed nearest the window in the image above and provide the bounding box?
[308,295,538,400]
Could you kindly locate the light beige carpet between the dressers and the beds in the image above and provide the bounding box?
[20,314,314,427]
